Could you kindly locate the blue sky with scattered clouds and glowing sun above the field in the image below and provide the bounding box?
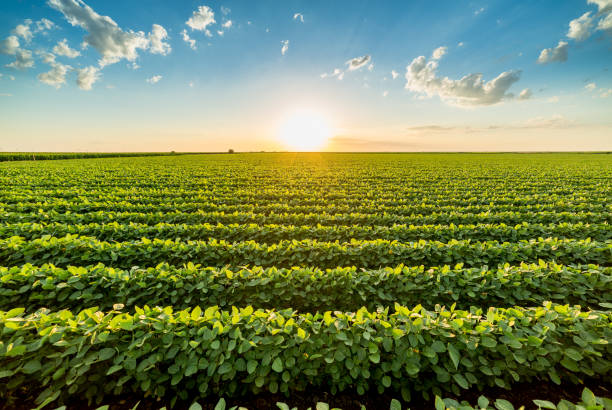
[0,0,612,152]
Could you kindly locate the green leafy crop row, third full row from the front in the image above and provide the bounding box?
[0,235,612,268]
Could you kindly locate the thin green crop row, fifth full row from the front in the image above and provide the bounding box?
[0,210,612,226]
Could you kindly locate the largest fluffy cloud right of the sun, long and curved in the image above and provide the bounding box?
[405,52,521,106]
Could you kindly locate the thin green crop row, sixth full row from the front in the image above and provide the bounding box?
[0,199,612,216]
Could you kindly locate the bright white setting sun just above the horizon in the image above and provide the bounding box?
[278,110,331,151]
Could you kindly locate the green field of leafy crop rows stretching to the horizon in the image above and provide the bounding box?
[0,153,612,408]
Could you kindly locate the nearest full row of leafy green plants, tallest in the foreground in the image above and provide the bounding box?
[0,303,612,403]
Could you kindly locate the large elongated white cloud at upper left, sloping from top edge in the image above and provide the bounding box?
[48,0,169,67]
